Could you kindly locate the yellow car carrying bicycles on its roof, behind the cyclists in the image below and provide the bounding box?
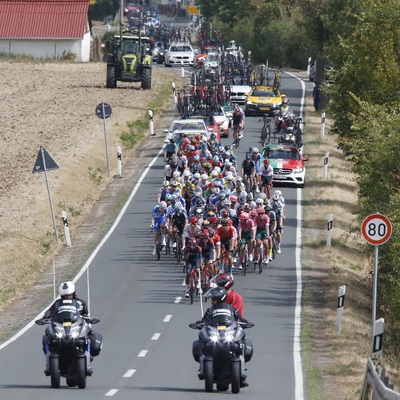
[245,86,286,117]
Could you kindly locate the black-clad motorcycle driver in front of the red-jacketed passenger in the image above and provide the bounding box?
[201,286,249,387]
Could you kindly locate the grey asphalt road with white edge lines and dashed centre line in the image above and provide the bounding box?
[0,73,303,400]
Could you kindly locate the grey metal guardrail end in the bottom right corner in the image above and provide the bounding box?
[360,358,400,400]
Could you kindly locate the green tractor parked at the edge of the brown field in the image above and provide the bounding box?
[106,30,152,89]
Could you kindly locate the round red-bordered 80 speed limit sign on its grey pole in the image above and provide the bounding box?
[361,213,392,348]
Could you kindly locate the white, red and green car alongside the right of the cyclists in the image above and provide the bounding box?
[261,144,308,187]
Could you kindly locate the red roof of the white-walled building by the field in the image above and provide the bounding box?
[0,0,89,39]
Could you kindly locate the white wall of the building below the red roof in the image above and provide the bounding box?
[0,33,90,62]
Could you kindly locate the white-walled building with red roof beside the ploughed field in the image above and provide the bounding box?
[0,0,91,62]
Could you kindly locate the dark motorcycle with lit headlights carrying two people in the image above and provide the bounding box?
[189,316,254,393]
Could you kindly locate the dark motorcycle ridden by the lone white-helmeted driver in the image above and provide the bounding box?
[35,300,103,389]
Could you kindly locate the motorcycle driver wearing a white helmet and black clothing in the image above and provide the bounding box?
[42,281,92,376]
